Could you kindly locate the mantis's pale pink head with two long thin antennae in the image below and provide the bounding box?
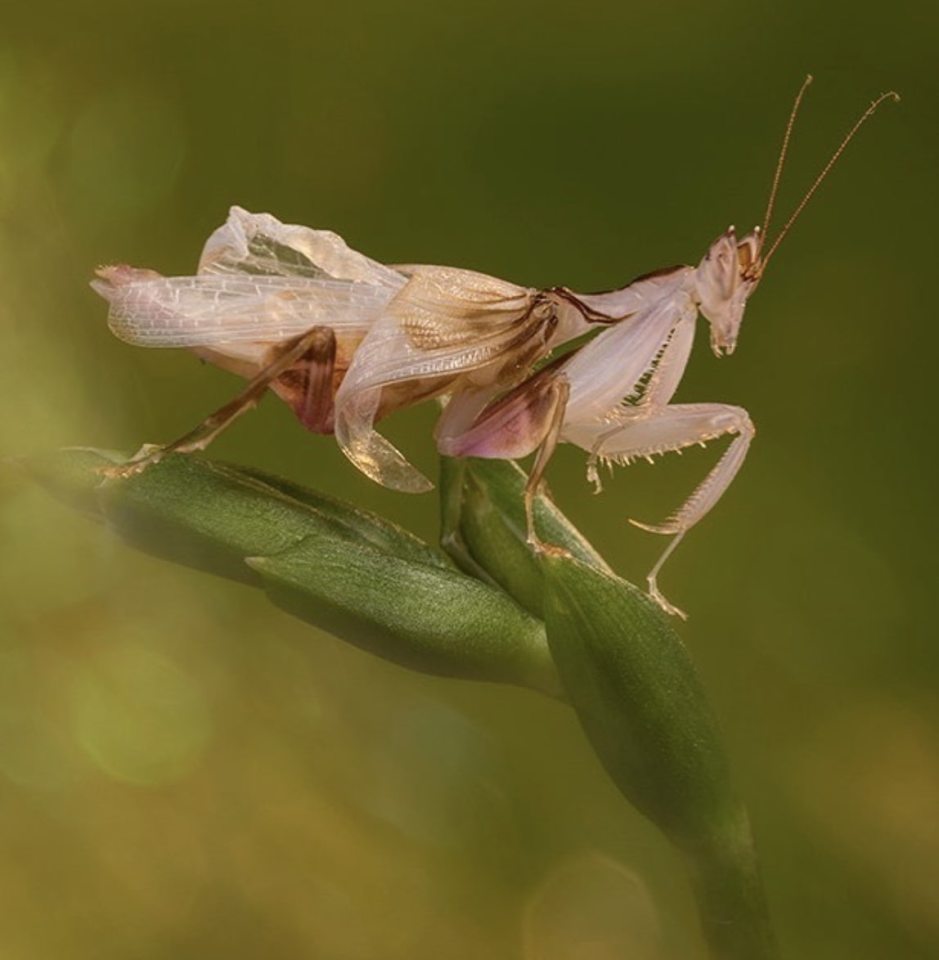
[694,76,900,356]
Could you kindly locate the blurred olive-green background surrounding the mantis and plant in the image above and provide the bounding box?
[0,0,939,960]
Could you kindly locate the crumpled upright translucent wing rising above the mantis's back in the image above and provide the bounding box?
[199,207,405,290]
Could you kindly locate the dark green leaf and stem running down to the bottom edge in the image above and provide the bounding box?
[543,555,774,960]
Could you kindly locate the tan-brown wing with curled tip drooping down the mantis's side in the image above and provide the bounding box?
[336,267,554,492]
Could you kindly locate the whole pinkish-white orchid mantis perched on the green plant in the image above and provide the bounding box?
[93,78,899,614]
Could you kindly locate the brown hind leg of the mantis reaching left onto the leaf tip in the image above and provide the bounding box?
[102,327,336,477]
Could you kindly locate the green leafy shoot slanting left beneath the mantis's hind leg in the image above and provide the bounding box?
[20,449,560,696]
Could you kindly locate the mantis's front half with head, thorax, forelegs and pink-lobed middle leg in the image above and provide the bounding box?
[437,76,899,617]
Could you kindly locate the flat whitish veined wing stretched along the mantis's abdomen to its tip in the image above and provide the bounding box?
[92,267,394,347]
